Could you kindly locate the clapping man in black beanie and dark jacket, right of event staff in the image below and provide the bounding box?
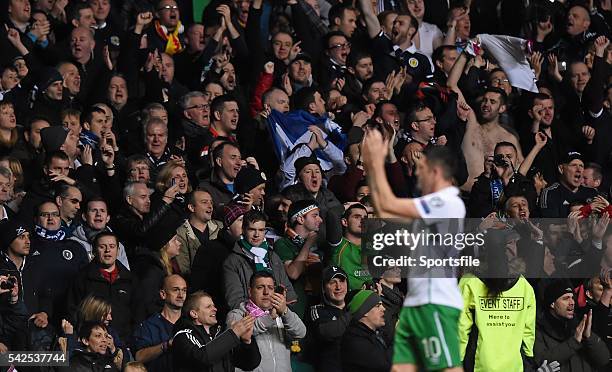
[534,279,610,371]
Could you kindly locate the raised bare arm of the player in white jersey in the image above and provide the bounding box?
[361,130,419,218]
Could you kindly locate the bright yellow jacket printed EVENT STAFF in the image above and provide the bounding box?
[459,276,536,372]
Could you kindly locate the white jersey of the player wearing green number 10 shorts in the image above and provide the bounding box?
[404,186,465,309]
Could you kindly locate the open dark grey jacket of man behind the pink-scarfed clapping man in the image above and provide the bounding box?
[223,242,297,309]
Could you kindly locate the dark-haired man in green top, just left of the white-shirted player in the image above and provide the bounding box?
[332,203,372,290]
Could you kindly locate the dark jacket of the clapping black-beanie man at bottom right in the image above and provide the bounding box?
[534,309,610,372]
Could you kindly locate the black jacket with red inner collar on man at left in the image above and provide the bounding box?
[68,261,136,340]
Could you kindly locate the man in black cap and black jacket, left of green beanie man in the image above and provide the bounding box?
[308,266,351,372]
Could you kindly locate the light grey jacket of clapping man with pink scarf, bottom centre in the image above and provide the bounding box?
[227,302,306,372]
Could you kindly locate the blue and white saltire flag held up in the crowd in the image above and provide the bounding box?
[268,110,347,170]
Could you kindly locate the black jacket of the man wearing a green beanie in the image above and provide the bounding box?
[341,321,393,372]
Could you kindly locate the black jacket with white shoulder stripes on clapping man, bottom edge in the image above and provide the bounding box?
[172,318,261,372]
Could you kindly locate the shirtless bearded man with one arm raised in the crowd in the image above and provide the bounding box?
[448,54,523,191]
